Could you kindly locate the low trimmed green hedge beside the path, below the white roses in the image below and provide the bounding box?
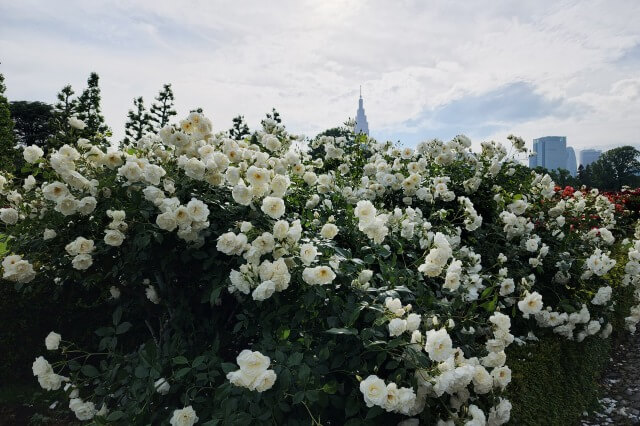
[507,268,634,426]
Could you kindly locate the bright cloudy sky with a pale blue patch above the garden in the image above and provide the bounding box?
[0,0,640,148]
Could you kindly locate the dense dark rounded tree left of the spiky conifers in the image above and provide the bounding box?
[11,101,53,148]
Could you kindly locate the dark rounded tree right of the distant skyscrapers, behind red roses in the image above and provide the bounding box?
[590,146,640,191]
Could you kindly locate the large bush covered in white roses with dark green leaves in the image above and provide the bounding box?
[0,113,640,425]
